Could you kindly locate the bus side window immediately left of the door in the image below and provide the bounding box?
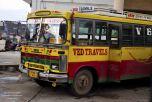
[94,21,107,45]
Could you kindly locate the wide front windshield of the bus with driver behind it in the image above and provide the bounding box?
[26,18,67,44]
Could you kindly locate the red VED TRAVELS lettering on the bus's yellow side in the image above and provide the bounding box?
[73,48,108,56]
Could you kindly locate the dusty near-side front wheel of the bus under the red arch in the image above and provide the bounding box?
[71,70,93,96]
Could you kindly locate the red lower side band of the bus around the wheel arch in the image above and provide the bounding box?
[68,60,152,81]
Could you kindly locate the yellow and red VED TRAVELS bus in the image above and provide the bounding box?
[19,10,152,96]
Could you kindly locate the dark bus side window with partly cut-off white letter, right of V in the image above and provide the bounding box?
[145,26,152,46]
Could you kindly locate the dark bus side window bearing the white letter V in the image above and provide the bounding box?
[134,25,144,46]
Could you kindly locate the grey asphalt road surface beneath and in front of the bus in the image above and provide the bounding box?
[0,71,150,102]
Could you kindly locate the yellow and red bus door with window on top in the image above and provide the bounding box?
[108,23,121,81]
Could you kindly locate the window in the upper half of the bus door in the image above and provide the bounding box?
[109,24,120,48]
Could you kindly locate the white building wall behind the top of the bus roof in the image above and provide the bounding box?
[32,0,114,11]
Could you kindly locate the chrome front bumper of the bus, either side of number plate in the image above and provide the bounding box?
[19,64,68,83]
